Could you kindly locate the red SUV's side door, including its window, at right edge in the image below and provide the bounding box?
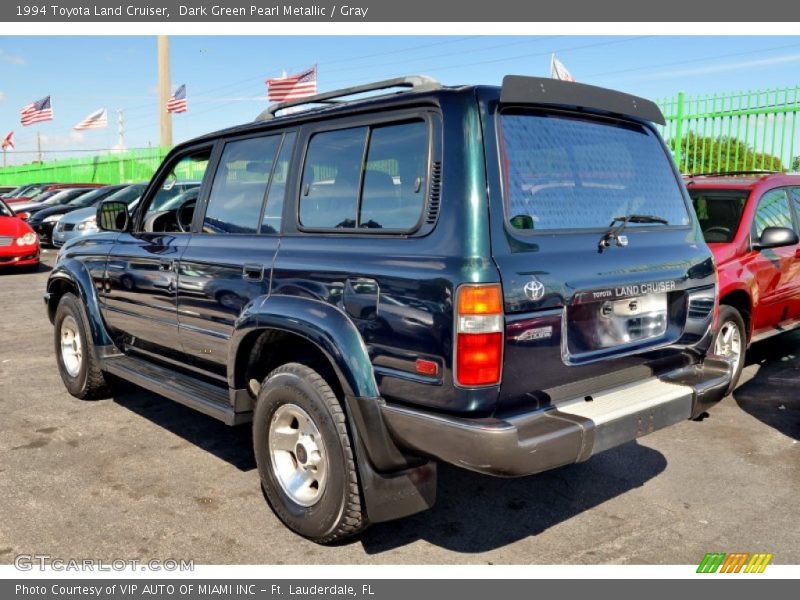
[750,188,800,334]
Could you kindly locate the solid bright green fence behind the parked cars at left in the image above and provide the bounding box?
[0,148,168,185]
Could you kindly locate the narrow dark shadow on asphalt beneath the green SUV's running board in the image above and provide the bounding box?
[114,381,256,471]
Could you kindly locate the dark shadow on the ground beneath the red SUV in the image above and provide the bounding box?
[733,333,800,440]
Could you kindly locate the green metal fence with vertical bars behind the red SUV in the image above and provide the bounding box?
[658,86,800,173]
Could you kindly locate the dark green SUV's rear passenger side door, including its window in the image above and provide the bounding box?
[178,132,295,376]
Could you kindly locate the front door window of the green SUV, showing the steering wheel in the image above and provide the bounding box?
[142,147,211,232]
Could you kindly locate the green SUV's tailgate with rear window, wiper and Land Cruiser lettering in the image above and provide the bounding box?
[485,107,714,410]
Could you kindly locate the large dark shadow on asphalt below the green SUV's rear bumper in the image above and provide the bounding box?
[358,442,667,554]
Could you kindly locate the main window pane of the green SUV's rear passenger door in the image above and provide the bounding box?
[202,135,281,233]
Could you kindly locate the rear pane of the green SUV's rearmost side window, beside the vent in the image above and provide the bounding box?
[358,121,428,229]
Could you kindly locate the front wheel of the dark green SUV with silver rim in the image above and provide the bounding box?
[54,293,111,400]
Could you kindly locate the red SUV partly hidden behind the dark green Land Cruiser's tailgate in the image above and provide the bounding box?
[686,172,800,391]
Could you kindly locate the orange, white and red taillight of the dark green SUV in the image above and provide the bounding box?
[455,283,503,387]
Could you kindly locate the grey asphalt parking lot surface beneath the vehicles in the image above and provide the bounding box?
[0,251,800,564]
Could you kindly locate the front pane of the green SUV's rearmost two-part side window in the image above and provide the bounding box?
[300,127,368,229]
